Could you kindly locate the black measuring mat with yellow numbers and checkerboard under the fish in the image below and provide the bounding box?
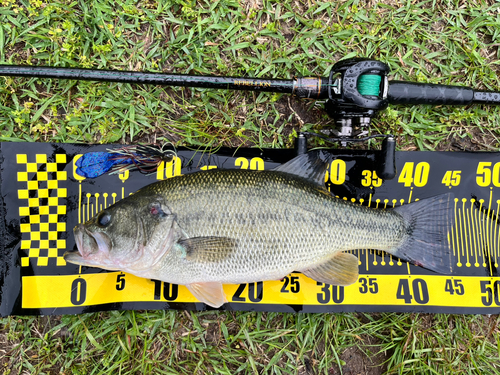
[0,143,500,316]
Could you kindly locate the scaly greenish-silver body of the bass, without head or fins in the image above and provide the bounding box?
[142,170,405,283]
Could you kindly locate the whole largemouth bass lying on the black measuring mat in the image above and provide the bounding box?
[64,152,453,307]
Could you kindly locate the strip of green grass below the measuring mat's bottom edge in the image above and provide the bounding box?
[2,311,499,374]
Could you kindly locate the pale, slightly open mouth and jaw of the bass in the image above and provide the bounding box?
[63,224,111,268]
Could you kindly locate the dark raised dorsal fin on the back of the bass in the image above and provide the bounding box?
[274,150,331,186]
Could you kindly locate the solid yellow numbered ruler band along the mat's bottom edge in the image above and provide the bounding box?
[22,272,500,309]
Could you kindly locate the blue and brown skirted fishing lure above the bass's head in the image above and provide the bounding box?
[76,143,176,178]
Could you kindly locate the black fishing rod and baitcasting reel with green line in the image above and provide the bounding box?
[0,58,500,179]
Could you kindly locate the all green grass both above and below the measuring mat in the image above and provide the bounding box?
[0,0,500,374]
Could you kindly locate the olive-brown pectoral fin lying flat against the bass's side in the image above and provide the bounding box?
[177,237,237,262]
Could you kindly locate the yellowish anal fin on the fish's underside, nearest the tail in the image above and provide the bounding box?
[301,252,358,286]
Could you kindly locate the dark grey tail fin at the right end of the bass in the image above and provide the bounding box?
[391,193,454,274]
